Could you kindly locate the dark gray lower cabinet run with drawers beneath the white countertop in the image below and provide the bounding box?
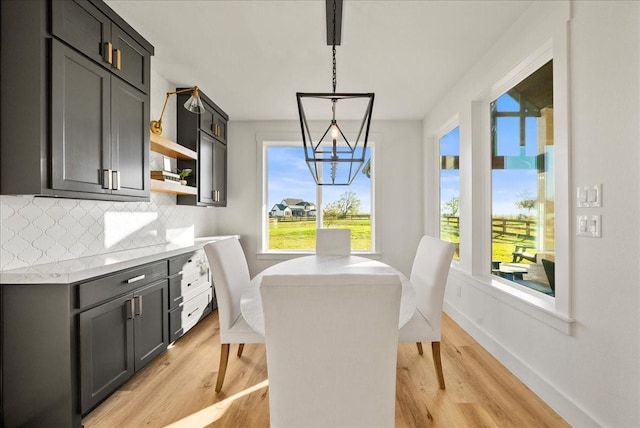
[0,250,216,428]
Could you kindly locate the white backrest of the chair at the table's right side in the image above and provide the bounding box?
[410,236,455,334]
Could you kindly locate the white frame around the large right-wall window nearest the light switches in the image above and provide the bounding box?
[460,37,574,334]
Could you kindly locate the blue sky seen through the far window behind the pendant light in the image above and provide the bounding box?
[267,143,371,214]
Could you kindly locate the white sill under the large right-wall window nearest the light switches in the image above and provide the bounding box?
[451,265,575,335]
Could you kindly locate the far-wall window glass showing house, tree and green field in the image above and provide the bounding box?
[263,142,375,252]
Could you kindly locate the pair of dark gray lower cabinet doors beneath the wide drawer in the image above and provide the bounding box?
[79,279,169,414]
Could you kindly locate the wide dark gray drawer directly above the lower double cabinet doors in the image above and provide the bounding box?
[79,260,167,308]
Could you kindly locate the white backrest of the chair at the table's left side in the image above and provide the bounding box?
[204,237,250,333]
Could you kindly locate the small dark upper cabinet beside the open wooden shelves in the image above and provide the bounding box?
[177,91,229,207]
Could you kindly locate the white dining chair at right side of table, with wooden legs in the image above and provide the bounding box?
[400,236,455,389]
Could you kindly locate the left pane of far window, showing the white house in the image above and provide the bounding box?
[267,145,316,250]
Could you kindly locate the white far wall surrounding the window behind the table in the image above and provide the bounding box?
[217,119,423,276]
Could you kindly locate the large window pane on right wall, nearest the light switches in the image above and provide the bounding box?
[491,61,555,296]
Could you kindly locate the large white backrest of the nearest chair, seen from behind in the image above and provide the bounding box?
[260,274,401,428]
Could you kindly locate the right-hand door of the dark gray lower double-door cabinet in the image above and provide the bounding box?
[133,279,169,371]
